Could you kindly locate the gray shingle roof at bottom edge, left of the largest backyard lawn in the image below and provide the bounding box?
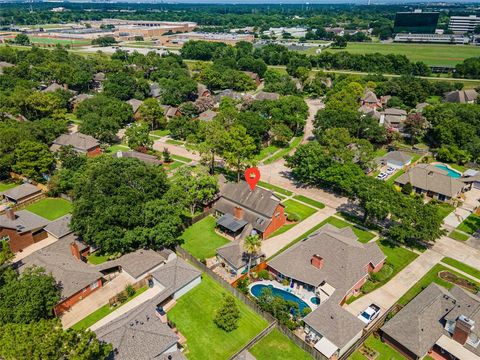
[95,302,178,360]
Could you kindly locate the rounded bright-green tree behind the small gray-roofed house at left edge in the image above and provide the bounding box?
[12,141,55,181]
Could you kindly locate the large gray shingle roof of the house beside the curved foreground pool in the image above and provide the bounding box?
[268,224,385,290]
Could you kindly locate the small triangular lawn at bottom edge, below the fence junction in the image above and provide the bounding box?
[249,329,312,360]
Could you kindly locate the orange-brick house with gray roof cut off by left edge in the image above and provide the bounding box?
[0,209,50,253]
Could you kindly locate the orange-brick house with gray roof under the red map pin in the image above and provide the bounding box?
[213,180,286,240]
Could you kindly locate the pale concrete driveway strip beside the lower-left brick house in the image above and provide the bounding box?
[61,273,132,329]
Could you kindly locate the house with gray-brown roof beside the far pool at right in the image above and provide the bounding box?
[395,164,466,201]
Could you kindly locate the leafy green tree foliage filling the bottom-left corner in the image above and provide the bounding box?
[0,320,112,360]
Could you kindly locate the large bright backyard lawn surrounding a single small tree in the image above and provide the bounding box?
[168,274,267,360]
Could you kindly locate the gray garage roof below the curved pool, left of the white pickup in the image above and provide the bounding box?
[303,299,365,349]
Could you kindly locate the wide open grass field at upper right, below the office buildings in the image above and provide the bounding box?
[307,43,478,66]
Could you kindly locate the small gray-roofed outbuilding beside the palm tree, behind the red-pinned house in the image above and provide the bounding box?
[217,239,265,275]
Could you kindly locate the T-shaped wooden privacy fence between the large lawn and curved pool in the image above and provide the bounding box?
[176,246,327,360]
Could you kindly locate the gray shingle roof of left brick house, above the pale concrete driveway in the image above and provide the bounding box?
[18,234,102,300]
